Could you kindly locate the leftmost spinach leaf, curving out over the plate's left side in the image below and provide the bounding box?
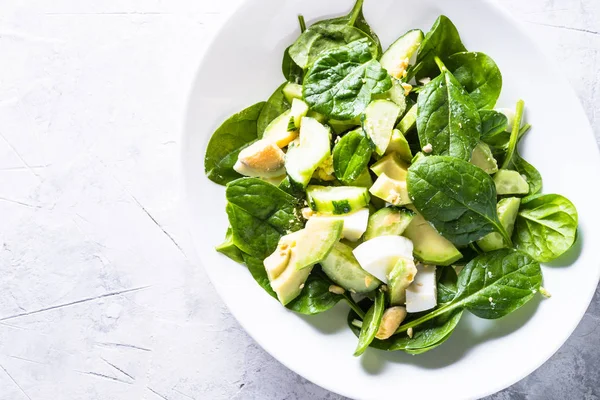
[204,102,265,185]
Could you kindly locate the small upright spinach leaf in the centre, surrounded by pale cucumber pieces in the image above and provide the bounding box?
[333,129,375,185]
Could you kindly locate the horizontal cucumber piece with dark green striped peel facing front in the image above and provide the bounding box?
[306,185,370,214]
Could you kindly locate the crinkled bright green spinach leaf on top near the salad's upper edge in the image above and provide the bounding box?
[303,39,392,120]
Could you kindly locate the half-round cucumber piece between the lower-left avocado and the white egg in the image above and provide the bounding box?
[321,242,381,293]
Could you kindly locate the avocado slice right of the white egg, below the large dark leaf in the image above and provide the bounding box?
[403,206,462,266]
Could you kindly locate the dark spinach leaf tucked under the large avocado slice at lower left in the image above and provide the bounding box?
[286,270,344,315]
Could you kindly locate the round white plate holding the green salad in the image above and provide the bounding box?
[183,0,600,399]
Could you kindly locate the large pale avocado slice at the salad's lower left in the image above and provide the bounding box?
[263,220,343,305]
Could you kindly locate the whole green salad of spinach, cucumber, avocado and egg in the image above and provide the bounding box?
[205,0,578,356]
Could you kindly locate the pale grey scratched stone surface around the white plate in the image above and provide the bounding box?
[0,0,600,400]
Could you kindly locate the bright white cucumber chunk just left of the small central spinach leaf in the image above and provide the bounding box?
[285,117,331,187]
